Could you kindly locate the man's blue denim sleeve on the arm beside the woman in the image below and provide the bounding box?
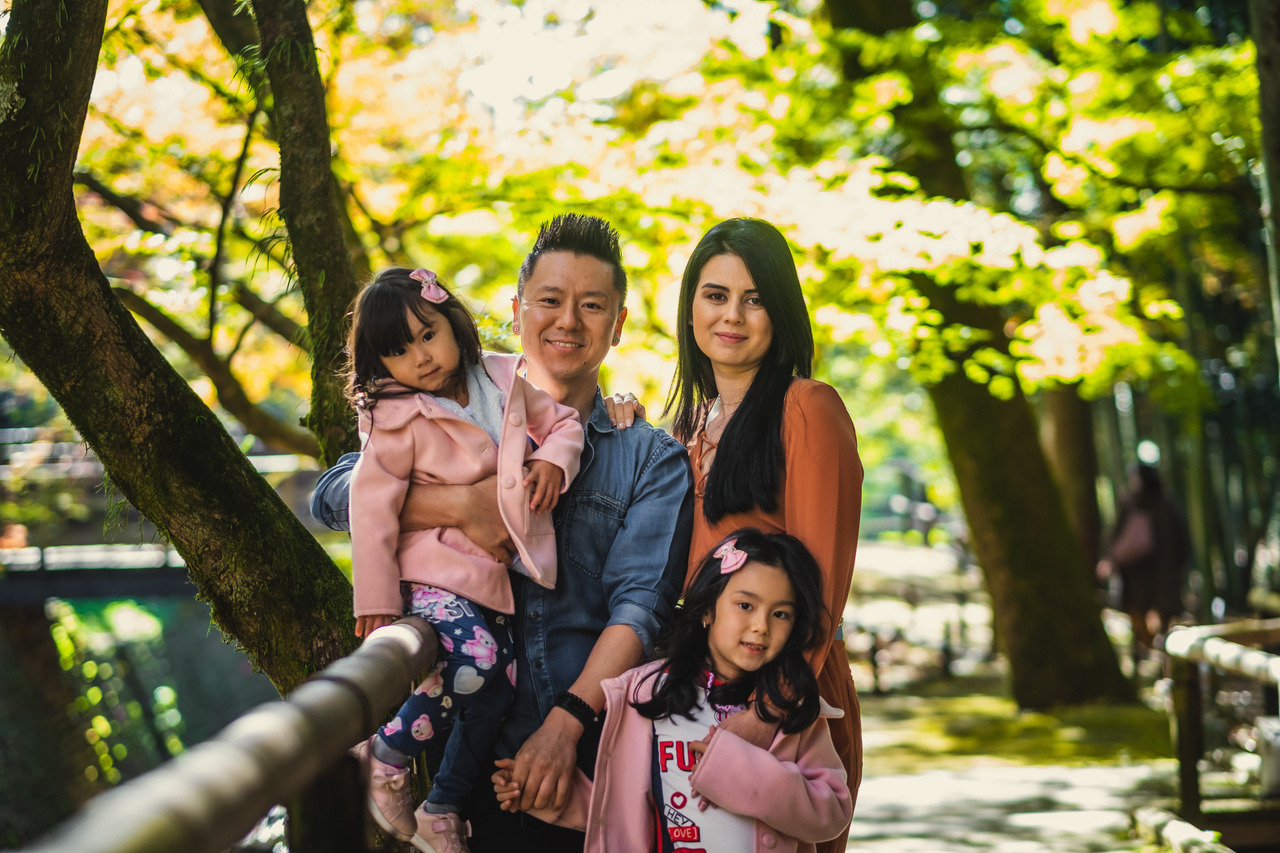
[600,427,694,657]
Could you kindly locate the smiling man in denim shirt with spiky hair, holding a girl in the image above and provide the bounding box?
[311,214,692,853]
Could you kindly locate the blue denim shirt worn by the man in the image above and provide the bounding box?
[311,392,692,758]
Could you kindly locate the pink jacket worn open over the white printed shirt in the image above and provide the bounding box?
[530,662,854,853]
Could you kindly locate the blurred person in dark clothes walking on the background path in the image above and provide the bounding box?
[1098,464,1190,649]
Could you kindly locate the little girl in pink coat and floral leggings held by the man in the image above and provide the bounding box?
[348,268,582,853]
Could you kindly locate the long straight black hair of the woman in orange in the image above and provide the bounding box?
[662,218,813,524]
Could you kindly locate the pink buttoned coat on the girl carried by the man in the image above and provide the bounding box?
[351,352,582,616]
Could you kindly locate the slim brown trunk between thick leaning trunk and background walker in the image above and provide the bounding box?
[1041,386,1102,568]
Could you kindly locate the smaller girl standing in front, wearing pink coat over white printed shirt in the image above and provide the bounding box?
[493,528,852,853]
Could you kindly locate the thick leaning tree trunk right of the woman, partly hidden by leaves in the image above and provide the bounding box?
[826,0,1133,708]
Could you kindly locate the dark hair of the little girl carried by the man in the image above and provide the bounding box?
[347,266,480,406]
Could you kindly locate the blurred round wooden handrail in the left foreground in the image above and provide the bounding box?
[24,616,436,853]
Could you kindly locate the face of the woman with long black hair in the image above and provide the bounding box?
[690,255,773,374]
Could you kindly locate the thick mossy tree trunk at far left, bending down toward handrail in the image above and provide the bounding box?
[0,0,355,692]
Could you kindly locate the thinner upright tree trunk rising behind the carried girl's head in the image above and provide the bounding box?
[252,0,358,465]
